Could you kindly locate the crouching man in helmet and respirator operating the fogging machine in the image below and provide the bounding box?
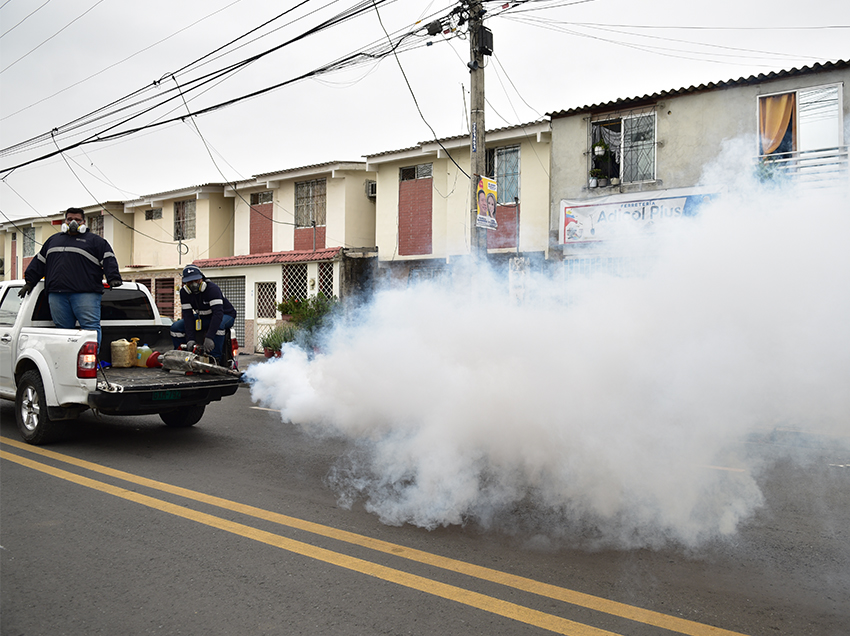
[171,265,236,360]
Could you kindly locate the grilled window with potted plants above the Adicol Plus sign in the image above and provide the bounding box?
[588,108,655,183]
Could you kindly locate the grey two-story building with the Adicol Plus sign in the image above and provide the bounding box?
[550,61,850,274]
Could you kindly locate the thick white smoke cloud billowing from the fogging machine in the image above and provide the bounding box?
[248,143,850,546]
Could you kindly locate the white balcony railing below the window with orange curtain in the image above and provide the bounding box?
[758,146,850,187]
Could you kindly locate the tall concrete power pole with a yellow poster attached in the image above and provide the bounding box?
[468,0,493,257]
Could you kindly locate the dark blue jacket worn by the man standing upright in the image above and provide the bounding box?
[24,232,121,294]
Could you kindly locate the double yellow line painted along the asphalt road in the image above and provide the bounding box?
[0,437,741,636]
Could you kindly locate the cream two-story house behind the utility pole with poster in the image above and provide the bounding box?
[366,121,550,280]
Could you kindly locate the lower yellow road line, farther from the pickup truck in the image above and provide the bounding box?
[0,451,618,636]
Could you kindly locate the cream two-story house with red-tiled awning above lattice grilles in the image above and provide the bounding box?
[193,161,375,350]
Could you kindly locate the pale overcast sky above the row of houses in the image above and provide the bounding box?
[0,0,850,222]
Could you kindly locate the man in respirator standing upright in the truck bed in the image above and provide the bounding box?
[18,208,121,347]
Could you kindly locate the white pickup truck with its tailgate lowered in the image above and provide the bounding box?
[0,280,240,444]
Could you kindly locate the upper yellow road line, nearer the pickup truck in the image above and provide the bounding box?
[0,437,742,636]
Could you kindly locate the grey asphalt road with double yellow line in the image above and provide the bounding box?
[0,370,850,636]
